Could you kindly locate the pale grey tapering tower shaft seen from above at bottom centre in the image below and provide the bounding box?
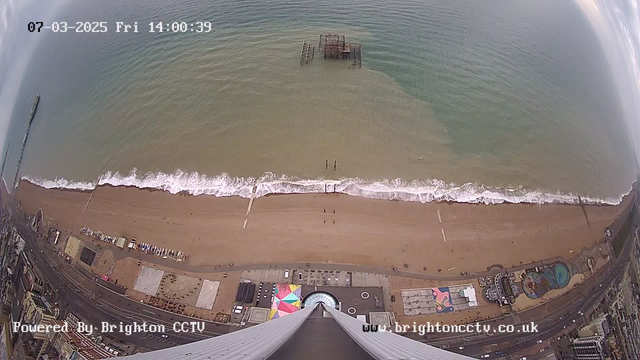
[115,303,470,360]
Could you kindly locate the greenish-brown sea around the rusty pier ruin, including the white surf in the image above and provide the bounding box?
[5,0,634,202]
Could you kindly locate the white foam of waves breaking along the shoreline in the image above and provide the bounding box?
[22,169,631,205]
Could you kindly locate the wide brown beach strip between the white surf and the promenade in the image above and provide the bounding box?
[17,181,631,274]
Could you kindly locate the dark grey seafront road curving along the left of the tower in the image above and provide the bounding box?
[14,221,232,350]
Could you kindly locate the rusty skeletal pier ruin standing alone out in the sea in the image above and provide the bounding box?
[300,34,362,69]
